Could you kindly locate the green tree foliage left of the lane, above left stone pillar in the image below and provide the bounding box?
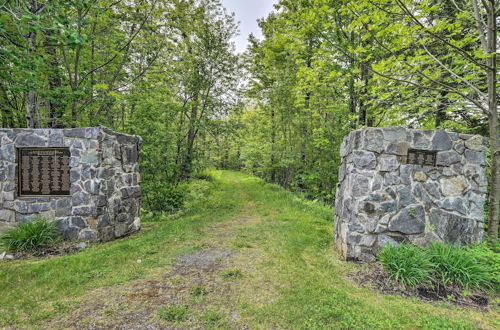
[0,0,241,214]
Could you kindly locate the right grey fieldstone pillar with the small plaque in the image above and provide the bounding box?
[335,127,487,261]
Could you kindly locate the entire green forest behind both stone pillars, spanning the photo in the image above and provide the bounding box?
[0,0,500,239]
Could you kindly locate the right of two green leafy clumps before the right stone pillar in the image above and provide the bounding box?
[428,243,492,289]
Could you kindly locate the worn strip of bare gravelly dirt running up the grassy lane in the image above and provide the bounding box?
[43,201,255,329]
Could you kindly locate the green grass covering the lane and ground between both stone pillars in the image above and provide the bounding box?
[0,172,500,329]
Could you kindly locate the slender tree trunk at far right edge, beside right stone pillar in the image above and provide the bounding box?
[486,0,500,243]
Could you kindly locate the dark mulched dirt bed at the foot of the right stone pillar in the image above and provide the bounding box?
[349,263,488,311]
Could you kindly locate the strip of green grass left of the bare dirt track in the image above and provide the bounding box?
[0,174,242,327]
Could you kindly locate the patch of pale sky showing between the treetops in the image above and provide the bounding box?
[222,0,278,53]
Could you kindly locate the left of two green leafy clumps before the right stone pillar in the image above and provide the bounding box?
[379,244,433,290]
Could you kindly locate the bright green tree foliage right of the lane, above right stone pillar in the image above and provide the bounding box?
[230,0,488,206]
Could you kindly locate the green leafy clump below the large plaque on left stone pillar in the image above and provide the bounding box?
[0,218,59,251]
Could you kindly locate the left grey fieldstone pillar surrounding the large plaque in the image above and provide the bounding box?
[0,127,141,241]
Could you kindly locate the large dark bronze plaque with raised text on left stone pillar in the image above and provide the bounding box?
[17,148,71,196]
